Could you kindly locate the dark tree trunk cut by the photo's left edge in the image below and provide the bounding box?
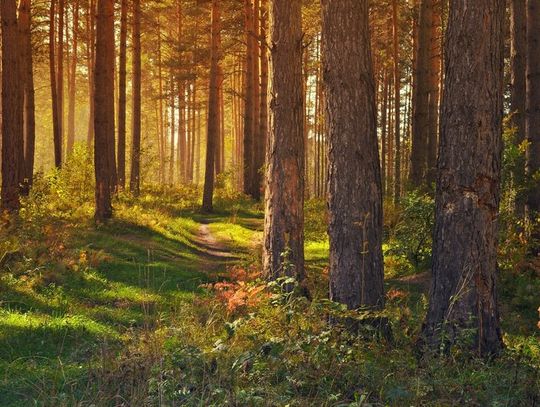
[0,0,24,211]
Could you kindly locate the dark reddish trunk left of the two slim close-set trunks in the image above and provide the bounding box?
[94,0,115,221]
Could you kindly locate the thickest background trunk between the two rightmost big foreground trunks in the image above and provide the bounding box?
[409,0,434,188]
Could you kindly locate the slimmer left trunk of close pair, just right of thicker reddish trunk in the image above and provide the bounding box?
[117,0,128,189]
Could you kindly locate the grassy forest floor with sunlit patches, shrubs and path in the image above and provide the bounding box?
[0,186,540,406]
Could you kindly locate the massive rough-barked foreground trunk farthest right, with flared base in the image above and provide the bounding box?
[423,0,505,355]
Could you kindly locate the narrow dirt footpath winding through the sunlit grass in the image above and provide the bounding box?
[194,220,240,273]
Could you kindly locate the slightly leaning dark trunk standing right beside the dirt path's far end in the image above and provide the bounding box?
[203,0,221,212]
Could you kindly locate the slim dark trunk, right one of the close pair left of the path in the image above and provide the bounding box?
[129,0,141,195]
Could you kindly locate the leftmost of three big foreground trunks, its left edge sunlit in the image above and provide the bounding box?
[263,0,305,281]
